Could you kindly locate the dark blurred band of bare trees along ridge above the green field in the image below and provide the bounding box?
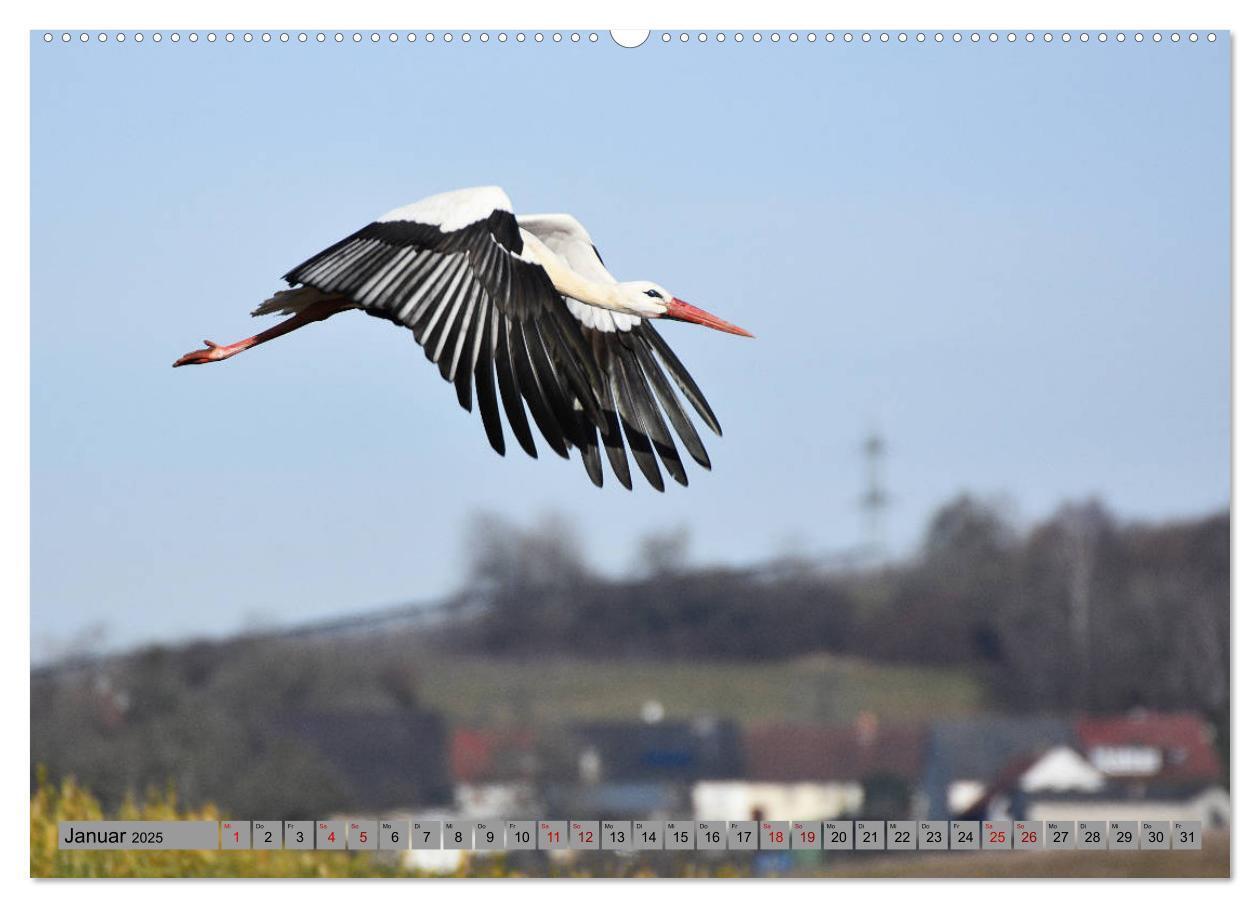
[440,496,1230,727]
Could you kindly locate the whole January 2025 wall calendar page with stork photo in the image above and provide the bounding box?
[28,8,1229,892]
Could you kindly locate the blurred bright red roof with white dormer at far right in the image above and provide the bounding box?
[1076,712,1222,782]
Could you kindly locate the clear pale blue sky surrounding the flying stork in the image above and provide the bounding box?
[32,35,1230,659]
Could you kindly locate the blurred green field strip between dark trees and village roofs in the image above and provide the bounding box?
[408,655,985,725]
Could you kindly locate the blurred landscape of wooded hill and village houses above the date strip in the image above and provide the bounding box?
[32,496,1230,860]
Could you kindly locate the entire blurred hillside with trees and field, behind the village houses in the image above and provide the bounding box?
[32,497,1230,816]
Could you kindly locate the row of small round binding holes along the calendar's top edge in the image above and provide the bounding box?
[43,31,1216,44]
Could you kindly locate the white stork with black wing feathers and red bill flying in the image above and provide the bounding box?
[175,186,752,491]
